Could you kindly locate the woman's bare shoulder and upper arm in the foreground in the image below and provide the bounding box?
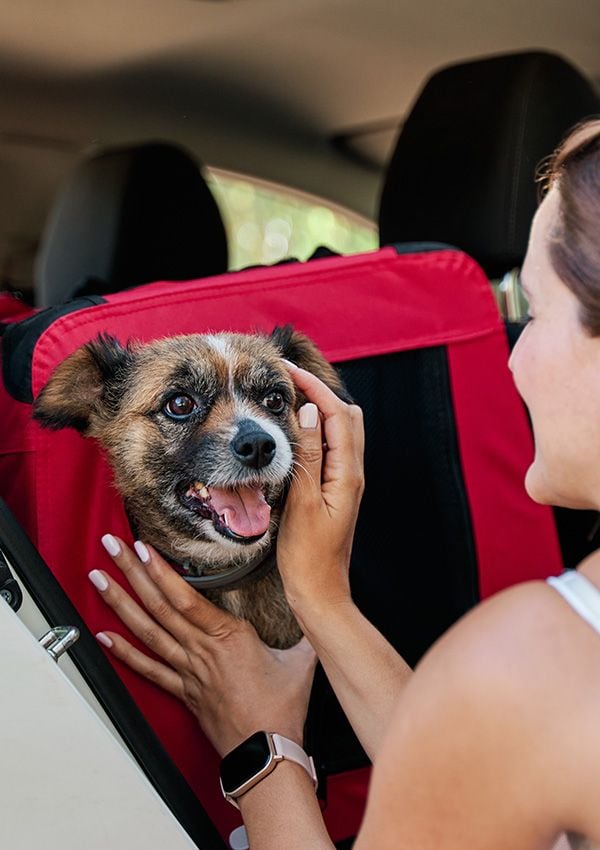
[364,582,600,847]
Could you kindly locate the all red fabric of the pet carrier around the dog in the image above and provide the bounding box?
[0,248,557,840]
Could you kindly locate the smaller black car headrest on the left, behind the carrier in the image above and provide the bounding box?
[36,142,227,307]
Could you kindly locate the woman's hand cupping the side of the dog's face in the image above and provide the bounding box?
[277,364,364,620]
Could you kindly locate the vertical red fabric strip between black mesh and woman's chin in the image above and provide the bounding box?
[448,331,563,599]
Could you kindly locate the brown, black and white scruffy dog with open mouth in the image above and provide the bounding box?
[34,326,350,649]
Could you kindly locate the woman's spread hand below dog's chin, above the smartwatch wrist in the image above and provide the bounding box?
[90,535,315,755]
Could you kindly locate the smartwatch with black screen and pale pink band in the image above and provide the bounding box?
[221,732,317,808]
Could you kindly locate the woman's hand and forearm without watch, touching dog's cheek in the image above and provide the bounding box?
[277,367,411,759]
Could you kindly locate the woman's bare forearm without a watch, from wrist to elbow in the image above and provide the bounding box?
[295,598,412,760]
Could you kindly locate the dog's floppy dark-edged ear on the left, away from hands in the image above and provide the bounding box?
[33,334,134,434]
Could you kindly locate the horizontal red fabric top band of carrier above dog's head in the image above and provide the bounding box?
[33,248,499,395]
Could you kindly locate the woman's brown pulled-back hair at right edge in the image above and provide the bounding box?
[544,119,600,336]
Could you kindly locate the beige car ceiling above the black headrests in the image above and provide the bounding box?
[0,0,600,290]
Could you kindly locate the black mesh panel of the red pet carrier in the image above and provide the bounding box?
[307,348,479,773]
